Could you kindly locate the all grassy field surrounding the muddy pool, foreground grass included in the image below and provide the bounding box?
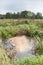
[0,19,43,65]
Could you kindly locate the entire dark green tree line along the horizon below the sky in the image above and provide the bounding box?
[0,10,43,19]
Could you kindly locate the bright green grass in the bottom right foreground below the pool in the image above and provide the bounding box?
[17,56,43,65]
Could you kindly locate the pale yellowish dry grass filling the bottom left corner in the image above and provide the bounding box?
[0,47,11,65]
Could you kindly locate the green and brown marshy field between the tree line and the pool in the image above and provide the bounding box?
[0,19,43,38]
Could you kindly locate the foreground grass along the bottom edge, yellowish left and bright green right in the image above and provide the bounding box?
[0,47,43,65]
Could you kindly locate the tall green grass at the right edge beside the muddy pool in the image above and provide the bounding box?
[35,37,43,55]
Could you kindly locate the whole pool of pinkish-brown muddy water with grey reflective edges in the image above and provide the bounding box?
[0,36,36,59]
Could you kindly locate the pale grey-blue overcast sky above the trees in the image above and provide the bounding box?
[0,0,43,14]
